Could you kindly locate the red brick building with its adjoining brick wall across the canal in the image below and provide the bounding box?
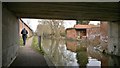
[66,24,100,39]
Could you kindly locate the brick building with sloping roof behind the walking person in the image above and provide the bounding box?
[19,19,33,37]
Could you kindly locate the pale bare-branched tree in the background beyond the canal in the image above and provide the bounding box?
[37,19,65,37]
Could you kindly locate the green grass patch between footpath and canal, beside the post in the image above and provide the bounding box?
[31,36,44,54]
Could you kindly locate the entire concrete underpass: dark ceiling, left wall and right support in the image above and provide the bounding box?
[2,2,120,66]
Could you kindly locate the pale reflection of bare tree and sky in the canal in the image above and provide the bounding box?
[42,39,78,66]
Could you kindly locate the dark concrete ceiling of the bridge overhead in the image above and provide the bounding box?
[3,0,120,21]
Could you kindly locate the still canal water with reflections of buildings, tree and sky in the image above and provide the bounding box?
[41,39,120,68]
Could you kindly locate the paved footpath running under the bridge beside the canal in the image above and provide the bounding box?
[10,37,48,68]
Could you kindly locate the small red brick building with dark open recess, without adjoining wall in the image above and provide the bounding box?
[66,25,91,39]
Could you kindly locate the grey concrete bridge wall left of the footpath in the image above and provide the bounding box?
[2,7,19,66]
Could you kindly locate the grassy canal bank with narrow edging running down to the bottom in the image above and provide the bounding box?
[31,36,55,68]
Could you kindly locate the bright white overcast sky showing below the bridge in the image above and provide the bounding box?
[22,18,100,32]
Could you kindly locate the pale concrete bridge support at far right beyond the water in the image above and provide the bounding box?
[108,22,120,56]
